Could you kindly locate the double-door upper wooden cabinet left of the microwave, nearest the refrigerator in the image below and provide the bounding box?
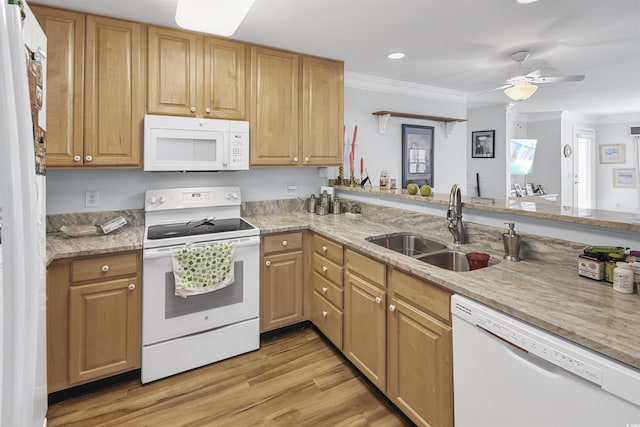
[32,6,146,168]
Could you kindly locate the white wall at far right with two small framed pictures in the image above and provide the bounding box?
[596,113,640,212]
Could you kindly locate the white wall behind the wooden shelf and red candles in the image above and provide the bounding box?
[342,73,467,196]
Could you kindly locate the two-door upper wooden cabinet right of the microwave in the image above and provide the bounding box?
[250,46,344,166]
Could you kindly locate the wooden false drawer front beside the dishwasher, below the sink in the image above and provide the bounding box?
[389,270,451,324]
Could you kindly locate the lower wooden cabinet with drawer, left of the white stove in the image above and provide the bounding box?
[47,251,142,393]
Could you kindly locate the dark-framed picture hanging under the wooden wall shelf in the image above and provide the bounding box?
[402,124,434,188]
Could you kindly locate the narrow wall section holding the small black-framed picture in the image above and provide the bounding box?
[467,105,508,199]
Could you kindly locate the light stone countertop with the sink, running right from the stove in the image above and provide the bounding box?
[244,212,640,369]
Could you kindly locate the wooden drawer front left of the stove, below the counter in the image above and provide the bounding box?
[71,253,138,282]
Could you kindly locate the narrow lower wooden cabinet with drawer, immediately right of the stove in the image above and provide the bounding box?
[260,232,304,332]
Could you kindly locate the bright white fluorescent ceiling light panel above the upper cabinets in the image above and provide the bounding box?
[176,0,255,37]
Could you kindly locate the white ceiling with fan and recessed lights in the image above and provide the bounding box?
[34,0,640,115]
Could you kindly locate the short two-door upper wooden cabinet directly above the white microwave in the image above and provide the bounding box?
[148,26,247,119]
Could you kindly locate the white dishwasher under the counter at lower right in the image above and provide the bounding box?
[451,295,640,427]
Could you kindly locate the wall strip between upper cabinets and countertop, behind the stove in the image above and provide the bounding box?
[47,168,327,214]
